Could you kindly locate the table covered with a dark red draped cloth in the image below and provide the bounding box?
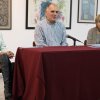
[13,46,100,100]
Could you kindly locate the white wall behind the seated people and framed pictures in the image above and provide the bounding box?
[1,0,100,53]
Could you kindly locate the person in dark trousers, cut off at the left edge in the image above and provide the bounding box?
[0,33,14,100]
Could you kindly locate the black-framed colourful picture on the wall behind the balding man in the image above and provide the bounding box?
[26,0,72,29]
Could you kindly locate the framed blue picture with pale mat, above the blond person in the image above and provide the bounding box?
[77,0,98,23]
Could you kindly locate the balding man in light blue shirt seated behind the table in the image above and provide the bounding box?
[34,2,67,46]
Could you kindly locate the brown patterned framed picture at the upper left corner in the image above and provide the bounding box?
[0,0,12,30]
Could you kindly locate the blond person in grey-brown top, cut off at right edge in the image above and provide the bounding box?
[87,14,100,44]
